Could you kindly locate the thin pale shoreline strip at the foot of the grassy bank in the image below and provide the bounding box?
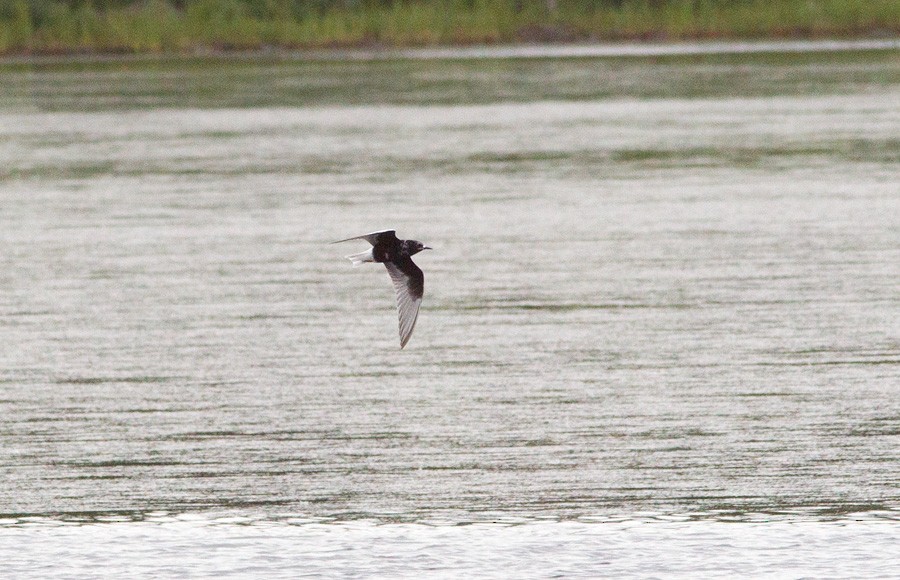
[0,36,900,66]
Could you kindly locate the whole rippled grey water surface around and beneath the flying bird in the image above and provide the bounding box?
[0,42,900,576]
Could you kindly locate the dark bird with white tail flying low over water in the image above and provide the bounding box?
[332,230,431,348]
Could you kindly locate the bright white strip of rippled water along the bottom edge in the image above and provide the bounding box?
[0,514,900,578]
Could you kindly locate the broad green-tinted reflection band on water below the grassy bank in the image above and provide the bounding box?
[0,40,900,111]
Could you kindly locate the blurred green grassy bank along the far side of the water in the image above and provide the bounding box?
[0,0,900,54]
